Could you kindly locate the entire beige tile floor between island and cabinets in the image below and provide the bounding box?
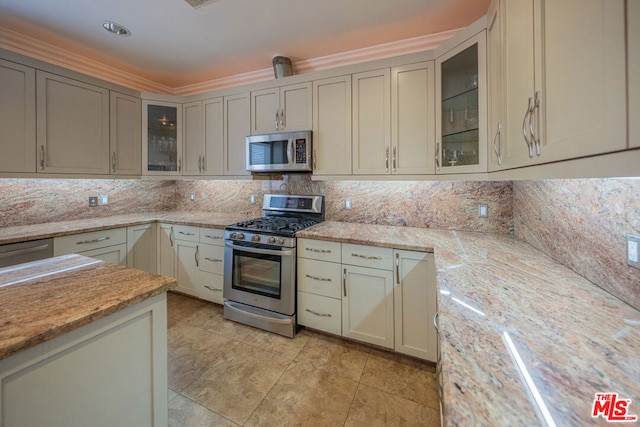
[168,293,440,427]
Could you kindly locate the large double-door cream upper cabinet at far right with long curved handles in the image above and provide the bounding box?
[494,0,633,168]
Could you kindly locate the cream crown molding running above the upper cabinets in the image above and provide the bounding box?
[0,26,459,96]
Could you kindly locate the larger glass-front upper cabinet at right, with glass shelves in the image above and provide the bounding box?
[436,31,487,173]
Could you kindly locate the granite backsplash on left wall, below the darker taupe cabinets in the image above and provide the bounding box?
[0,179,176,227]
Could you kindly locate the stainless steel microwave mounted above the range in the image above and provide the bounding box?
[247,131,312,172]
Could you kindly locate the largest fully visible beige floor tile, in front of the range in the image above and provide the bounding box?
[182,343,288,424]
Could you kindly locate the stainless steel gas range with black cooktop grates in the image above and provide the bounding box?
[223,194,324,338]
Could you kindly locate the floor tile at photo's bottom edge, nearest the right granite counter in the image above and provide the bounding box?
[344,384,440,427]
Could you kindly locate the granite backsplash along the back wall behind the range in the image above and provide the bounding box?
[176,176,513,233]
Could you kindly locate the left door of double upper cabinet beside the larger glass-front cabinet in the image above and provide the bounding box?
[351,68,391,175]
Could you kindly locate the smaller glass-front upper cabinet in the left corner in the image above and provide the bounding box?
[142,101,182,175]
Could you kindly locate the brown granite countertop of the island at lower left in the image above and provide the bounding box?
[0,255,176,359]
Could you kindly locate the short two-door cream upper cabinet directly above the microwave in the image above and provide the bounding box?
[251,83,312,135]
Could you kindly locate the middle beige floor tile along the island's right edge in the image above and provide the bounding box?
[167,322,238,393]
